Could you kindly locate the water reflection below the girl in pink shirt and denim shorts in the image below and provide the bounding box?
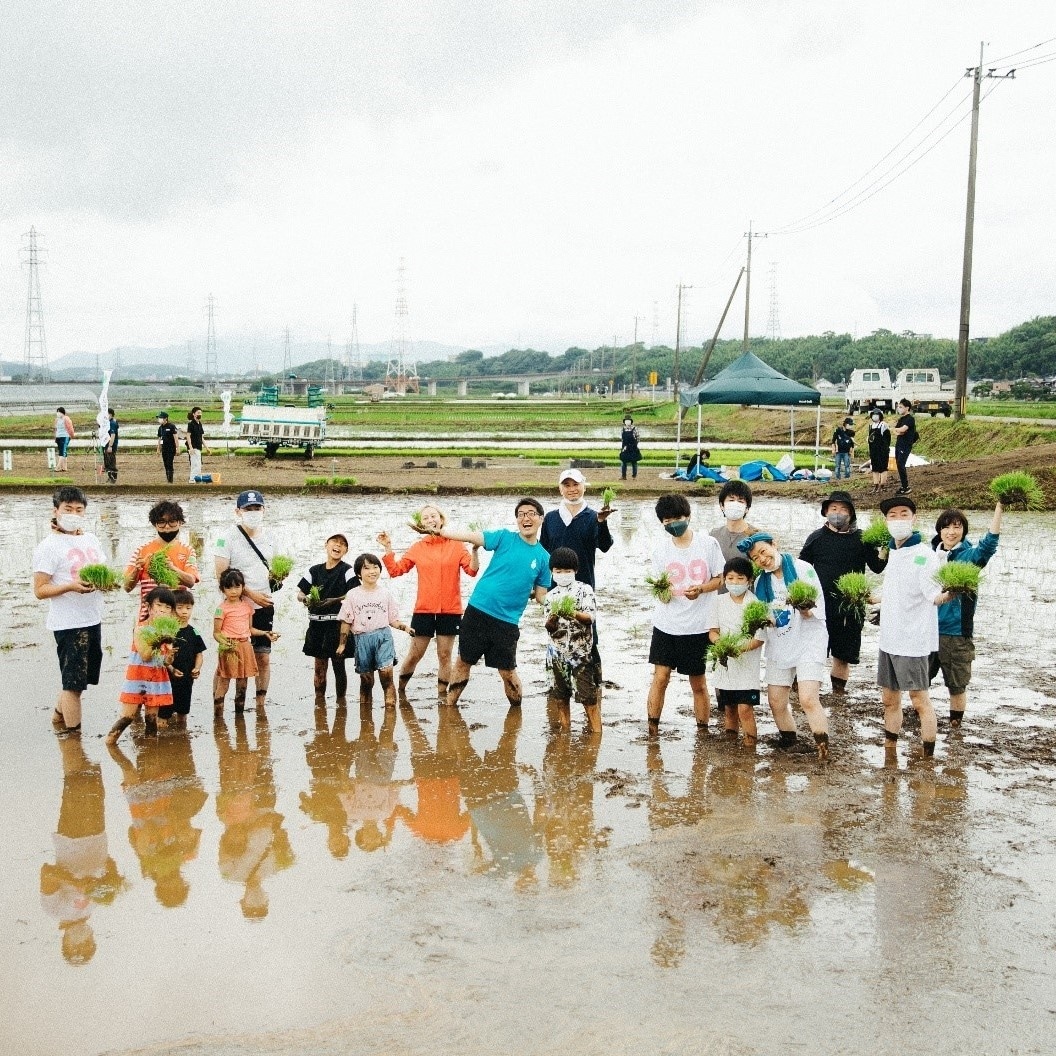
[341,703,399,851]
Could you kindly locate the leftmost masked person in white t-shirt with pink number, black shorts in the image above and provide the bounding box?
[33,487,105,733]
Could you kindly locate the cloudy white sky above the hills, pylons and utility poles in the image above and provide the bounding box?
[0,0,1056,360]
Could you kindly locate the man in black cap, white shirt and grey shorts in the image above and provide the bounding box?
[876,495,950,762]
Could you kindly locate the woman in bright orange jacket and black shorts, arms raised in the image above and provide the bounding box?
[378,503,480,703]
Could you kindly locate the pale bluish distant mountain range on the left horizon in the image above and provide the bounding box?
[0,341,507,381]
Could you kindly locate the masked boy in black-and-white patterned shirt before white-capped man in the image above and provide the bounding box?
[544,546,601,733]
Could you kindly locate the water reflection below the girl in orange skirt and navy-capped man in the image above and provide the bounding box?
[213,714,295,919]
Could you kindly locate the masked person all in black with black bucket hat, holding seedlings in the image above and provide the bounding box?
[799,491,887,696]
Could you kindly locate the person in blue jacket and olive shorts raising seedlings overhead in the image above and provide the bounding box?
[928,503,1002,730]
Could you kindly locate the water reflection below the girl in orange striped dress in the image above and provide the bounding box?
[110,736,209,908]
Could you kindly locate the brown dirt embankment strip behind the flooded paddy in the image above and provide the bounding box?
[0,444,1056,509]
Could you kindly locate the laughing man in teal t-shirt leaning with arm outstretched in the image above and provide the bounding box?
[416,498,552,708]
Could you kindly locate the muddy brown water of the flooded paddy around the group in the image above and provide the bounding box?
[0,498,1056,1054]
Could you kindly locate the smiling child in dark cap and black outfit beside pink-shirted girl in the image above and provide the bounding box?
[297,532,359,708]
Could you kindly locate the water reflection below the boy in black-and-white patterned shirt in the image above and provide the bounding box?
[532,730,607,887]
